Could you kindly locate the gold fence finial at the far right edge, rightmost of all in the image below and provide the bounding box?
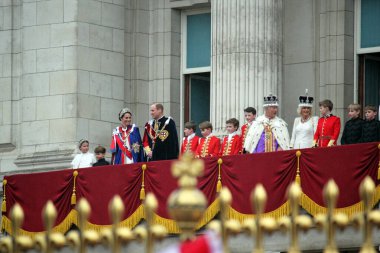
[353,176,380,253]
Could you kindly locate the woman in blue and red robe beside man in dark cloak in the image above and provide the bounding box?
[110,108,144,164]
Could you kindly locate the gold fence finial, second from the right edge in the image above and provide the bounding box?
[315,179,348,253]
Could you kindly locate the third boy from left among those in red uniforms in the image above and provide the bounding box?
[219,118,241,156]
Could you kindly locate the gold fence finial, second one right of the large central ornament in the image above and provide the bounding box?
[243,184,277,253]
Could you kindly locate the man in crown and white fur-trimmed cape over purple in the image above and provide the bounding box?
[244,95,289,153]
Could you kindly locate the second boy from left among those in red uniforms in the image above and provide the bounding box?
[196,121,220,158]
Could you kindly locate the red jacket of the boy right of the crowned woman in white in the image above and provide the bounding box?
[314,114,340,147]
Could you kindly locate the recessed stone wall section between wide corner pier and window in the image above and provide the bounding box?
[125,0,181,128]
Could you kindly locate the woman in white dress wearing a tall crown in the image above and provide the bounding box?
[290,91,318,149]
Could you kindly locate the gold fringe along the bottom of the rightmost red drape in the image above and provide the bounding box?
[300,185,380,217]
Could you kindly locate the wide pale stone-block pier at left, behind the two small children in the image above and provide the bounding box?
[11,0,125,170]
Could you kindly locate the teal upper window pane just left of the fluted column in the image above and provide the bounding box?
[186,13,211,68]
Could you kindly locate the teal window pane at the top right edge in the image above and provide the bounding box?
[361,0,380,48]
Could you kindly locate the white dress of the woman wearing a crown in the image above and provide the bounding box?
[290,116,318,149]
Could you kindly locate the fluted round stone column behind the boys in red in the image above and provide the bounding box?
[211,0,283,133]
